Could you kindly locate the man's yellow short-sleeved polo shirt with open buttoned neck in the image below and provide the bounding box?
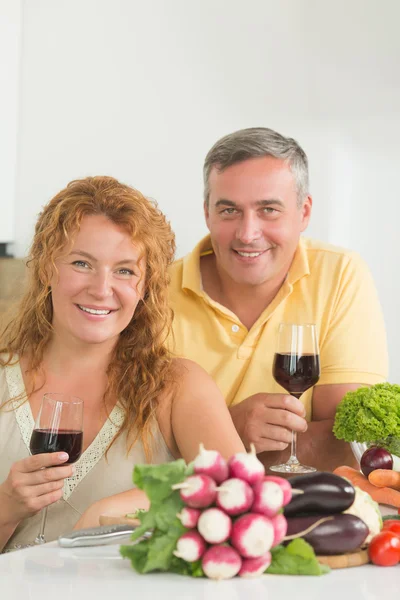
[170,236,388,420]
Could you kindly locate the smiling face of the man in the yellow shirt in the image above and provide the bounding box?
[204,156,312,286]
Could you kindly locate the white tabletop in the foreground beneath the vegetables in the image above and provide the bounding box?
[0,542,400,600]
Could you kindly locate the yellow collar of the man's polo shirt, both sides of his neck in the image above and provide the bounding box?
[182,235,310,296]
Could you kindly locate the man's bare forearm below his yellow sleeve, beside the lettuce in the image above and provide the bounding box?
[259,383,364,471]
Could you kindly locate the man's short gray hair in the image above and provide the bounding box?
[203,127,309,206]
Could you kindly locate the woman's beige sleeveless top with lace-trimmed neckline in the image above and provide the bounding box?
[0,363,173,552]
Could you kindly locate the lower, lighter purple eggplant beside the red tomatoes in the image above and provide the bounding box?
[286,513,369,555]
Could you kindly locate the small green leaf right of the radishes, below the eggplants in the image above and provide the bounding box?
[265,538,330,575]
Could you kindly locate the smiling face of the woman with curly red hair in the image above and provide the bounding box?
[51,215,146,345]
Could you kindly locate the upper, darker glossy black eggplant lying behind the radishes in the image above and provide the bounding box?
[284,471,356,517]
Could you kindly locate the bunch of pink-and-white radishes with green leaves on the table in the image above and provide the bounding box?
[121,447,329,579]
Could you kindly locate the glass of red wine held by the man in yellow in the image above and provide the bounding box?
[270,323,320,473]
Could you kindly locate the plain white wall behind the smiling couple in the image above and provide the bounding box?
[3,0,400,381]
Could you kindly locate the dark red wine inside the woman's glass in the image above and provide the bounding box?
[29,429,83,465]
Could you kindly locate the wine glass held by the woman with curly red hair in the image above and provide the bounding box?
[29,394,83,544]
